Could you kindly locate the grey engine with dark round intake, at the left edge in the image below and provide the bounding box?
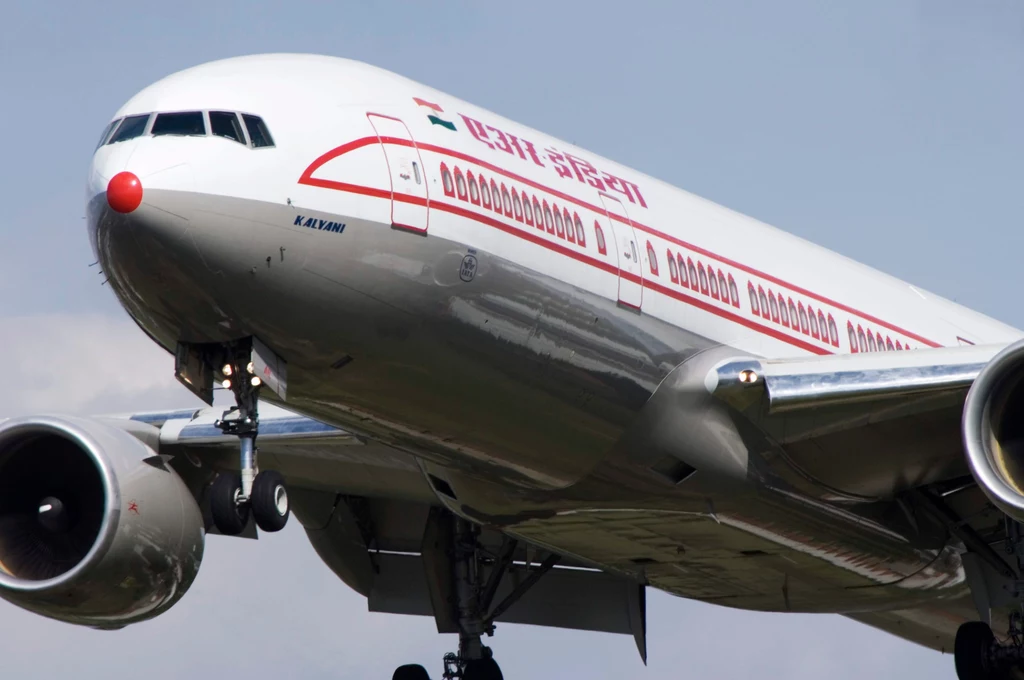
[0,416,205,628]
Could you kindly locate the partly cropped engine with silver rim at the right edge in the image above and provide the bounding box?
[963,341,1024,522]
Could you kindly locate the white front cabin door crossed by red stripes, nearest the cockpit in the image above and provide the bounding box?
[367,114,428,233]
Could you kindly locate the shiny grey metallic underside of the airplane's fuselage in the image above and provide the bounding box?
[89,190,991,648]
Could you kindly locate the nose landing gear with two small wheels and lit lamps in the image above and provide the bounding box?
[210,351,290,536]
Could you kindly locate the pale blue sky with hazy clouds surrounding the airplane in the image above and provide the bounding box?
[0,0,1024,680]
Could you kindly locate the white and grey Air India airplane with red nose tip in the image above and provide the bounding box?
[0,54,1024,680]
